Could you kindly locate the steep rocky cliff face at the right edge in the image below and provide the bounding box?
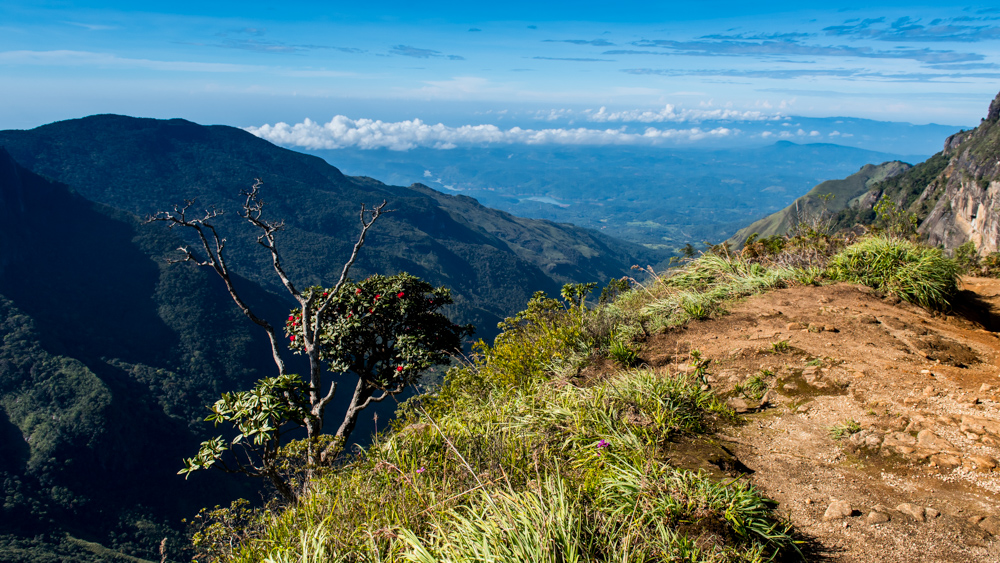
[918,94,1000,253]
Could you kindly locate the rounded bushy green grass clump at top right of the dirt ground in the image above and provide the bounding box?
[827,235,958,309]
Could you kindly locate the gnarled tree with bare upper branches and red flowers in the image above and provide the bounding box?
[147,180,472,502]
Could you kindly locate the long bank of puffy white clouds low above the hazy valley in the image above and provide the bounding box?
[246,115,740,151]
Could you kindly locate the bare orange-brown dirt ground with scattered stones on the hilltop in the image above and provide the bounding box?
[642,278,1000,563]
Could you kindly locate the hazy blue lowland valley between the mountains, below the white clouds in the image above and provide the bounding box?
[311,140,928,251]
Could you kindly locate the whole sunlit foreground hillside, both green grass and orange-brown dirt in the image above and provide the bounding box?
[184,235,1000,562]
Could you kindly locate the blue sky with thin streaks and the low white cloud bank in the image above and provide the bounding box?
[0,0,1000,148]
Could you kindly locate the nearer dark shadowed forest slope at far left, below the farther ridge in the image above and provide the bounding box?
[0,150,274,561]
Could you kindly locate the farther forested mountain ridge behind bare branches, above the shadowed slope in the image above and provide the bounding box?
[0,115,657,331]
